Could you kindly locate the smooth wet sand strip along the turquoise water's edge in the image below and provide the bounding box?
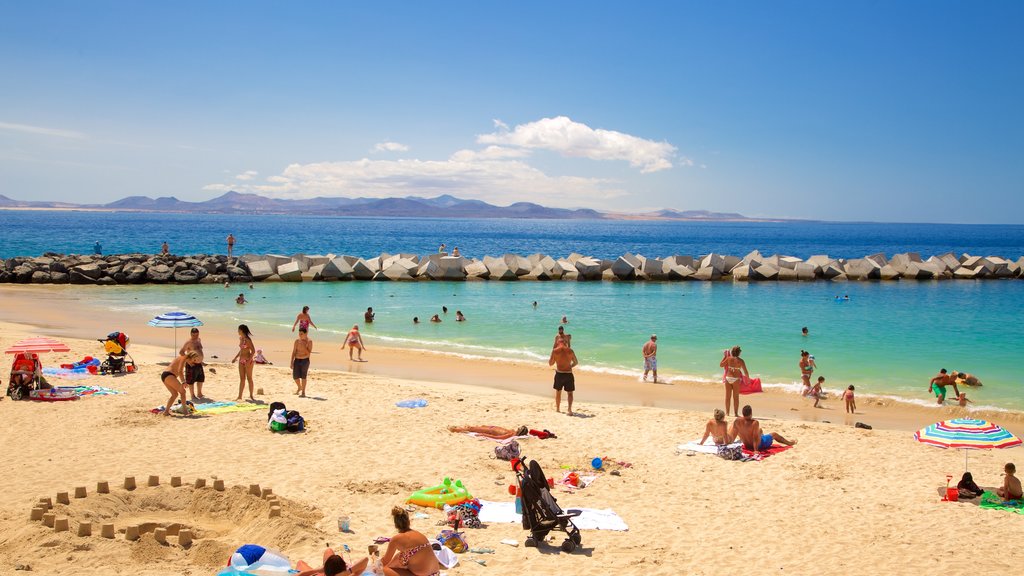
[0,286,1011,430]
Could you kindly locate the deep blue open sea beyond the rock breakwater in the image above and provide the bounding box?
[0,210,1024,259]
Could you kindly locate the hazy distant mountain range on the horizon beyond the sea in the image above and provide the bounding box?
[0,192,765,220]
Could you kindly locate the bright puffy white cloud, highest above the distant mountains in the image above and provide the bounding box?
[476,116,688,173]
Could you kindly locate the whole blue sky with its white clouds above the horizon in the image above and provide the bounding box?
[0,0,1024,223]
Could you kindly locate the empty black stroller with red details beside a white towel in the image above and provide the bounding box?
[512,456,581,552]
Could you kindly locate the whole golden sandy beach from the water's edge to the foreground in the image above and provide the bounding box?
[0,287,1024,575]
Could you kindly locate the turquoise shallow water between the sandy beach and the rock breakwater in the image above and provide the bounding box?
[90,281,1024,410]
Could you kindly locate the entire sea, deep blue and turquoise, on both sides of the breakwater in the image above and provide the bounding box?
[6,210,1024,410]
